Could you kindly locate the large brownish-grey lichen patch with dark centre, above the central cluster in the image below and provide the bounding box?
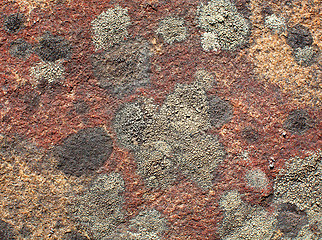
[92,40,152,97]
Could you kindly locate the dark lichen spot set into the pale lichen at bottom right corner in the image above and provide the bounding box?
[276,203,308,238]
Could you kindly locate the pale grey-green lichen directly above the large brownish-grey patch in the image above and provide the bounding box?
[91,6,131,50]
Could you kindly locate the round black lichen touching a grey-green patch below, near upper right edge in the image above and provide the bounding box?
[286,24,313,49]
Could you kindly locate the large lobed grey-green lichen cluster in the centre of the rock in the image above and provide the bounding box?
[114,81,226,189]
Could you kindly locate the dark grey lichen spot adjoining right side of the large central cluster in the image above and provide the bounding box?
[208,96,233,128]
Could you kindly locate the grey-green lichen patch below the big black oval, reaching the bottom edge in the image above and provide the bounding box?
[70,172,125,239]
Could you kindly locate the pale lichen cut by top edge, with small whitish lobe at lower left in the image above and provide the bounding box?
[198,0,250,51]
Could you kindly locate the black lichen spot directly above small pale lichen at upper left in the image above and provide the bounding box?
[35,32,71,62]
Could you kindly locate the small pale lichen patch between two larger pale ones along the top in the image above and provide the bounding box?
[156,17,187,44]
